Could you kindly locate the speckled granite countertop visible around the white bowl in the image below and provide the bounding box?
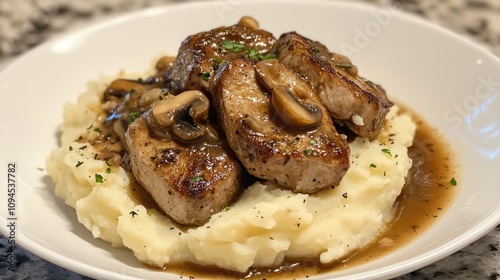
[0,0,500,280]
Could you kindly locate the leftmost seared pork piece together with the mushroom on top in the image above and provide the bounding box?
[126,91,242,225]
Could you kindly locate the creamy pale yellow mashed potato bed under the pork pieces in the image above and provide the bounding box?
[47,71,416,272]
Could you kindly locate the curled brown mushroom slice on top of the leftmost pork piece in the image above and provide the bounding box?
[150,90,210,141]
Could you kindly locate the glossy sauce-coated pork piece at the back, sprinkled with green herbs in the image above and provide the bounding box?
[169,17,276,92]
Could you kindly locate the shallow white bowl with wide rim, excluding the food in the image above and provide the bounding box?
[0,0,500,279]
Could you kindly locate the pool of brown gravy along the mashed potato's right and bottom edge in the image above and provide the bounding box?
[165,110,458,279]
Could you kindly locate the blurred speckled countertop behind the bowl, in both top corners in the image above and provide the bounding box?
[0,0,500,65]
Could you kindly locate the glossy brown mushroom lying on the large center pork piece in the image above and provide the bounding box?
[256,59,323,129]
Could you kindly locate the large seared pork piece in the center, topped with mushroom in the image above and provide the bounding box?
[211,59,349,193]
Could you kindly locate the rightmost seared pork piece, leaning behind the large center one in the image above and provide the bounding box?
[274,32,393,140]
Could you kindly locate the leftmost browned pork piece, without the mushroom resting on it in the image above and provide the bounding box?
[126,117,241,225]
